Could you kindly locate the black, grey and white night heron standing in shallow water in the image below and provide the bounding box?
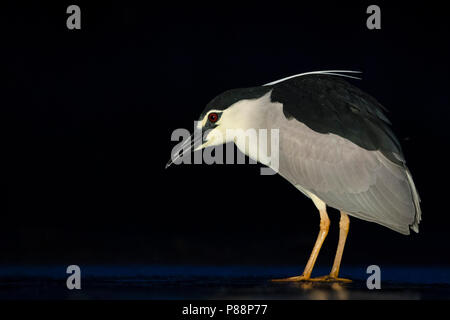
[166,70,422,282]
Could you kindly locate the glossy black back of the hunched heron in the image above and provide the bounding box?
[271,74,403,164]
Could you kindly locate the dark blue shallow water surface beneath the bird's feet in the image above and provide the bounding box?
[0,265,450,300]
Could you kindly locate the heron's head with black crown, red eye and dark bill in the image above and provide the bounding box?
[166,86,271,167]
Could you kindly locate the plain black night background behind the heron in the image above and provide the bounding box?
[0,1,450,270]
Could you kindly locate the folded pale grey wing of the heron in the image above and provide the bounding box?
[279,120,421,234]
